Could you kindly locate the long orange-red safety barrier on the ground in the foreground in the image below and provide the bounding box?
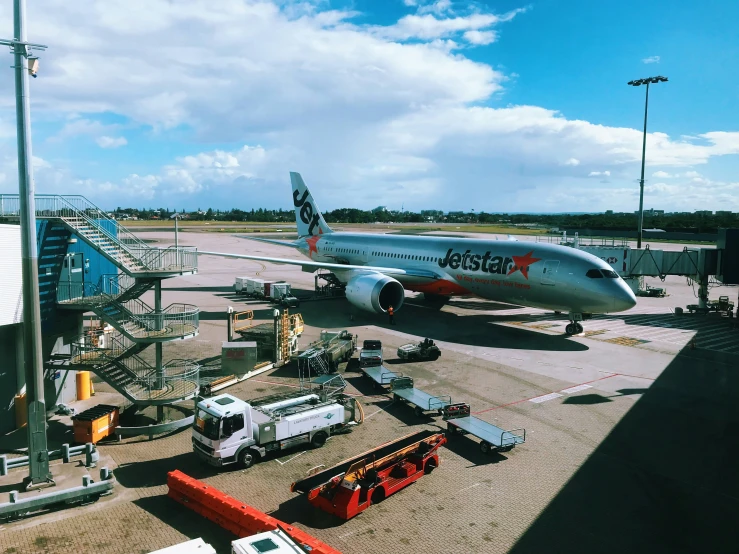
[167,470,341,554]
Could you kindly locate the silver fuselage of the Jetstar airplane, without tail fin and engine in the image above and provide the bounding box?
[298,232,636,313]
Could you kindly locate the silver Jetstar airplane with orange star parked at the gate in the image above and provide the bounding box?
[198,172,636,335]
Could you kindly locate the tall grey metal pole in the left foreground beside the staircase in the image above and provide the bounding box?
[0,0,54,490]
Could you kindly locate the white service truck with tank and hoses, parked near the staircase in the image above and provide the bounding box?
[192,394,359,468]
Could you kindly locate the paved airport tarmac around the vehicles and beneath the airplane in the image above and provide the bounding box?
[0,226,739,554]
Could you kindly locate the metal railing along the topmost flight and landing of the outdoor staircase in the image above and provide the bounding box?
[0,194,197,271]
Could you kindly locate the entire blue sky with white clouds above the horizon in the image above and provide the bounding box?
[0,0,739,212]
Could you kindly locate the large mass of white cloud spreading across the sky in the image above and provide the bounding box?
[0,0,739,211]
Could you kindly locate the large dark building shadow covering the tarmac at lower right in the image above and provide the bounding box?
[510,350,739,554]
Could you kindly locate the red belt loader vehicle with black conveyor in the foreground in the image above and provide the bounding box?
[290,431,447,519]
